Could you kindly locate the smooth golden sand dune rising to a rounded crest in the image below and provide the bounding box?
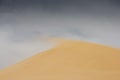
[0,40,120,80]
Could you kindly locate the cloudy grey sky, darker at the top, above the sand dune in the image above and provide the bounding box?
[0,0,120,69]
